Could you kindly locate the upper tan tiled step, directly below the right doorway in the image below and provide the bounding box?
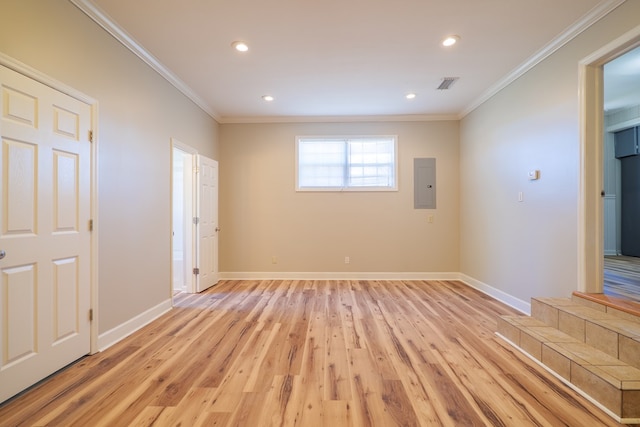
[531,298,640,369]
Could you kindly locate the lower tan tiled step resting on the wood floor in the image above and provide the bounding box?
[498,314,640,423]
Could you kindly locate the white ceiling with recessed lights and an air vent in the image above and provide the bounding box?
[72,0,632,123]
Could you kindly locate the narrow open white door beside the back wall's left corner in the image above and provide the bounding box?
[195,155,220,292]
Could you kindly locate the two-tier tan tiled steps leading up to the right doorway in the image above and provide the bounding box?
[498,298,640,423]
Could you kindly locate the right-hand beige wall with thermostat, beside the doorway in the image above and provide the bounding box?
[460,1,640,302]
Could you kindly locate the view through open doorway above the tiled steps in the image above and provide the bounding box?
[603,47,640,302]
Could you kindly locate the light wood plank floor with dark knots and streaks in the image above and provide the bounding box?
[0,281,618,427]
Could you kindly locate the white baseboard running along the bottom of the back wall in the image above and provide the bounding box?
[219,271,461,280]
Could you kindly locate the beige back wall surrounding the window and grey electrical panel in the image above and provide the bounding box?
[220,121,459,274]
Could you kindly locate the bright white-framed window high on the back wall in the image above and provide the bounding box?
[296,136,398,191]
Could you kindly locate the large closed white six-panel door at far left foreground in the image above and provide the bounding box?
[0,66,91,402]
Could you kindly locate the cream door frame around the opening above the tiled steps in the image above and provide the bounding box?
[578,26,640,293]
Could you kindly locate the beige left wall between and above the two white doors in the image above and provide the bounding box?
[0,0,218,333]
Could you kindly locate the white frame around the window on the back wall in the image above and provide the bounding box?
[295,135,399,192]
